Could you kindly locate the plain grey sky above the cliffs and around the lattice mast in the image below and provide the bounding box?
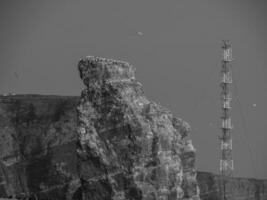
[0,0,267,178]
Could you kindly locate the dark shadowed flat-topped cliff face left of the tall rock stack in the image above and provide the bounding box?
[0,95,79,199]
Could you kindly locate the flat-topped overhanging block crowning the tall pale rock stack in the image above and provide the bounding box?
[78,56,135,86]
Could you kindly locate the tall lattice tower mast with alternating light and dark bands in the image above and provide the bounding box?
[220,40,234,200]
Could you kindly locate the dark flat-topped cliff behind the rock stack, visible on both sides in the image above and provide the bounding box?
[0,95,267,200]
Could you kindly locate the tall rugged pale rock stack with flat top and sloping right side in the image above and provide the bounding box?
[77,56,199,200]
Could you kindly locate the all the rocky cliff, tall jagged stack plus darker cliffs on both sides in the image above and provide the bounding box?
[0,57,267,200]
